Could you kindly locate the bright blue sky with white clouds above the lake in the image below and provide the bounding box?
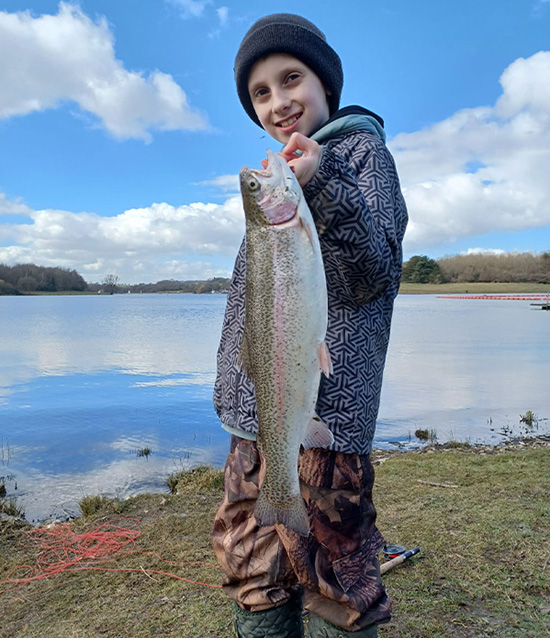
[0,0,550,284]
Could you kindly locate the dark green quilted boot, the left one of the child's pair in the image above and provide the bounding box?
[233,598,304,638]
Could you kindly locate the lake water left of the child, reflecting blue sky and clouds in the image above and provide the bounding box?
[0,295,228,519]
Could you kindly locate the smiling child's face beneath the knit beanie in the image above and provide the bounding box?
[248,53,329,144]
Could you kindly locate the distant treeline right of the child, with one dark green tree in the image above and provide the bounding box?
[402,251,550,284]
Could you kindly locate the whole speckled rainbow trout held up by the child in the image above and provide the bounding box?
[239,150,334,536]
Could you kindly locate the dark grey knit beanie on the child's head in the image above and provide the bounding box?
[234,13,344,126]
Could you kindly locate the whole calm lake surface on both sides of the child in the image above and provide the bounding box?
[0,295,550,520]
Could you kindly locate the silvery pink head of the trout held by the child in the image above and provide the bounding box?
[240,150,302,226]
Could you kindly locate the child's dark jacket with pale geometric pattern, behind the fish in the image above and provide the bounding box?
[214,107,407,454]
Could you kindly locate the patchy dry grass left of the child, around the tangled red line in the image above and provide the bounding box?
[0,482,231,638]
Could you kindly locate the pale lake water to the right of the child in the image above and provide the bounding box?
[379,296,550,442]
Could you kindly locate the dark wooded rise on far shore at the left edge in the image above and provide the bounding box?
[0,264,88,295]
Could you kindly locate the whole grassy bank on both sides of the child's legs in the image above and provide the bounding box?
[0,437,550,638]
